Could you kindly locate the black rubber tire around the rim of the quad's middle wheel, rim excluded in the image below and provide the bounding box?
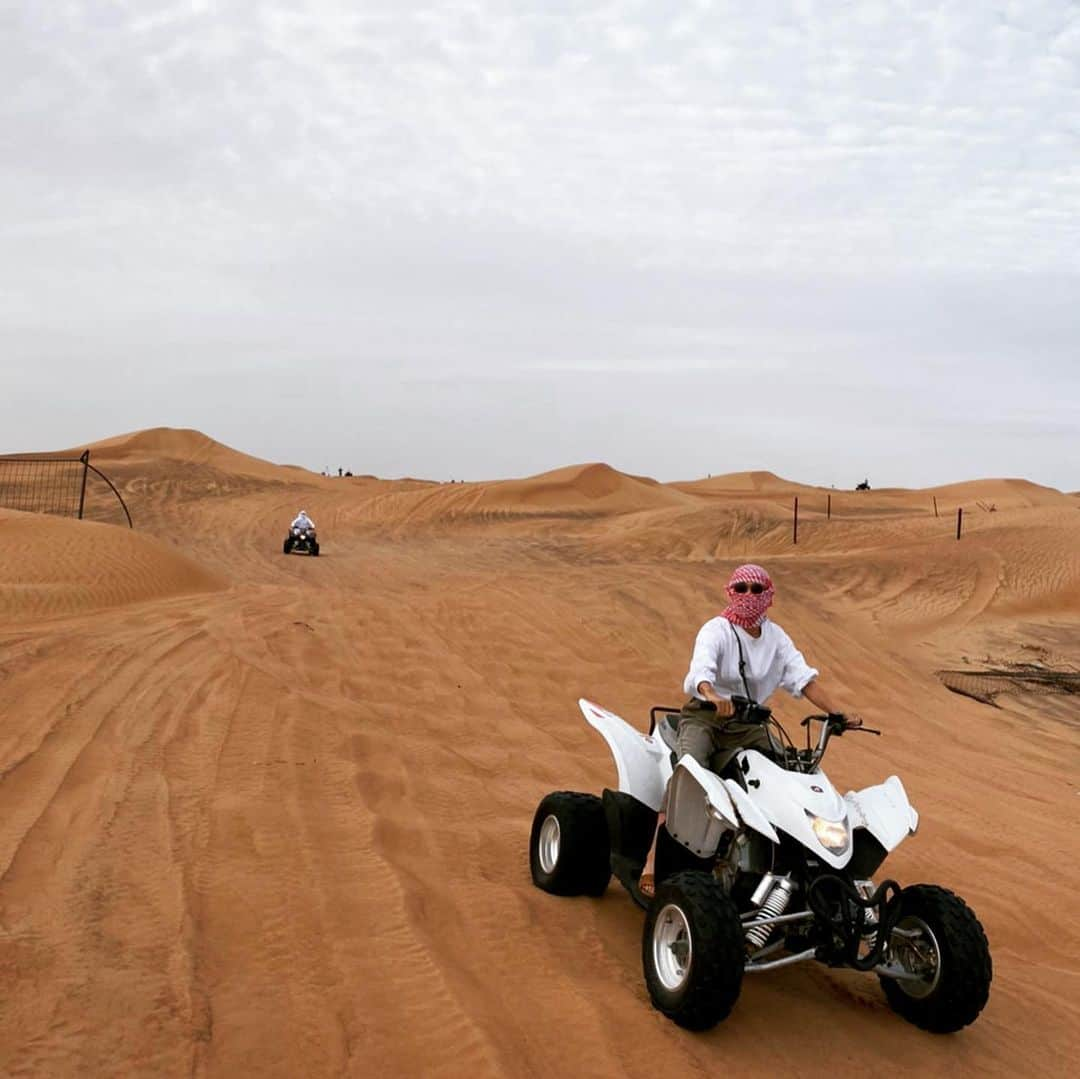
[642,869,746,1030]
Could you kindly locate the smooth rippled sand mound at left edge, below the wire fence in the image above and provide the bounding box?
[0,510,228,618]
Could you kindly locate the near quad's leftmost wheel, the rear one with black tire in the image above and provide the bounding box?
[529,791,611,895]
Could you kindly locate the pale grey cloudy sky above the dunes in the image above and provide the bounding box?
[0,0,1080,490]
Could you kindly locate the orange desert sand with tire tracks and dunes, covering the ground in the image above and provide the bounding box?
[0,430,1080,1079]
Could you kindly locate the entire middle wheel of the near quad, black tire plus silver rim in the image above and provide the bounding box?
[642,869,746,1030]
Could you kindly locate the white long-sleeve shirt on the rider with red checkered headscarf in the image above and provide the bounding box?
[683,617,818,704]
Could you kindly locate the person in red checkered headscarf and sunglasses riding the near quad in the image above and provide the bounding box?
[637,564,863,899]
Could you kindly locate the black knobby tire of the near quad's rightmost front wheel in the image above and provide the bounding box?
[879,885,994,1034]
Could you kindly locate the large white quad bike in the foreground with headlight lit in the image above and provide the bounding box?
[529,698,991,1034]
